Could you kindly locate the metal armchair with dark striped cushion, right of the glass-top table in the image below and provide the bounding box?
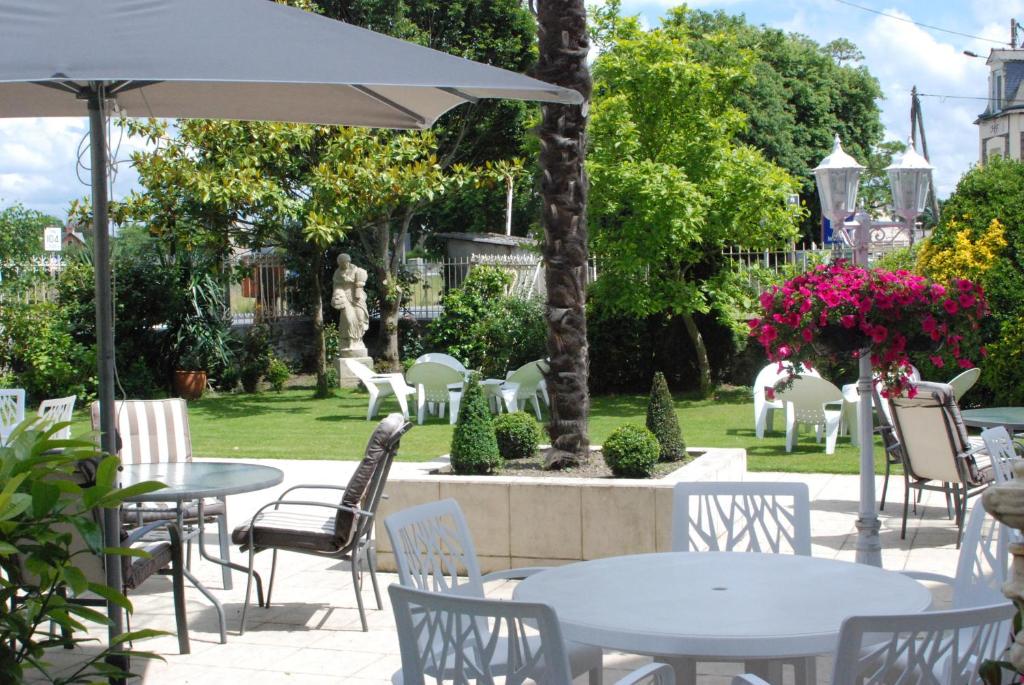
[231,414,413,634]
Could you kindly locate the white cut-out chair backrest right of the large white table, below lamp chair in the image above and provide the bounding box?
[951,503,1010,609]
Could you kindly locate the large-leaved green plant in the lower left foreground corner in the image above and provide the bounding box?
[0,420,162,685]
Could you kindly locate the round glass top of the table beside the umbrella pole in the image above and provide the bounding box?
[121,462,285,502]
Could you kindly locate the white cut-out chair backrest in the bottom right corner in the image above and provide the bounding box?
[831,601,1015,685]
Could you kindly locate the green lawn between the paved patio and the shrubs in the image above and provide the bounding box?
[70,388,882,473]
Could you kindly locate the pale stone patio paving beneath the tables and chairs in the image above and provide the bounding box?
[32,460,974,685]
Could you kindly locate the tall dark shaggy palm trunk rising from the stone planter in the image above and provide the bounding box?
[536,0,591,468]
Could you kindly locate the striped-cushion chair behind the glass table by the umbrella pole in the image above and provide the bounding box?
[89,397,231,590]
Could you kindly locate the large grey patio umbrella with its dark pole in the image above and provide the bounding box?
[0,0,583,663]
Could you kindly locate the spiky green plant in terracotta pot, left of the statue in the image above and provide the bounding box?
[170,271,231,399]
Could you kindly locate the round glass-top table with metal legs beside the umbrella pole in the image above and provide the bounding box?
[121,462,285,643]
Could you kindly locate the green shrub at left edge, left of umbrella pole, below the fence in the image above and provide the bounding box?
[0,301,96,402]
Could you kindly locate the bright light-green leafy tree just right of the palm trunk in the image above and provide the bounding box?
[588,5,800,394]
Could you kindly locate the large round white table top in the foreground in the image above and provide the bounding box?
[515,552,932,658]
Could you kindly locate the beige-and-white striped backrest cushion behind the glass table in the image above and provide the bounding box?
[91,397,191,464]
